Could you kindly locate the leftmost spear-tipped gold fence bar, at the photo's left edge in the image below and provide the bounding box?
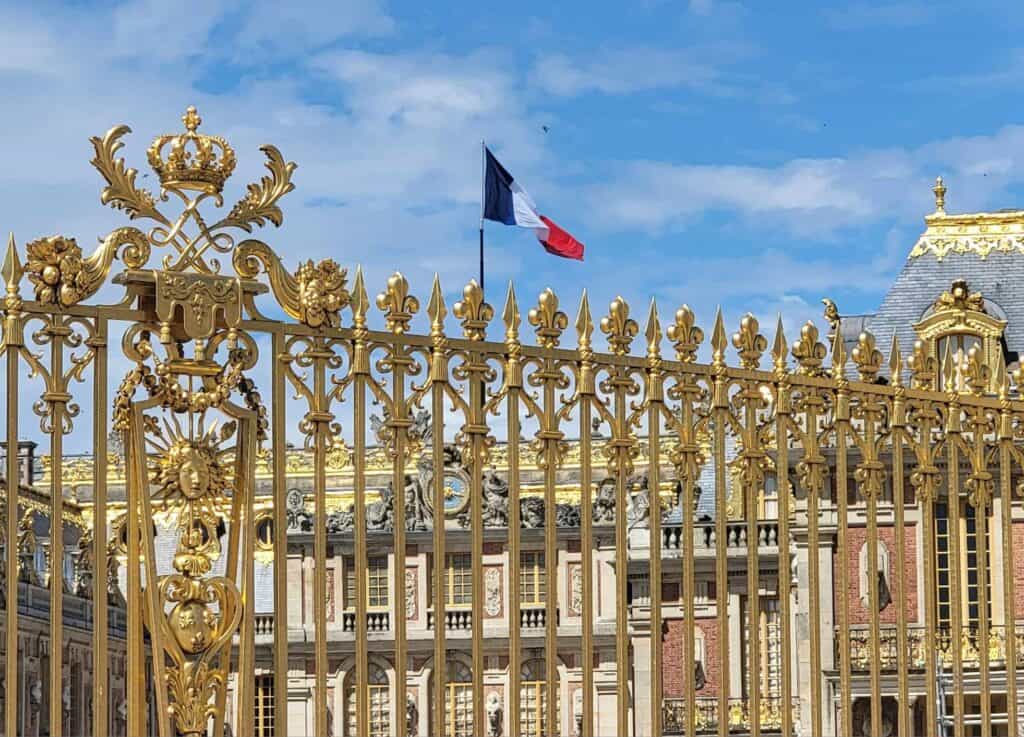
[3,290,23,735]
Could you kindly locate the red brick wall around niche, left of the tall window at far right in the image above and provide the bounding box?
[833,525,925,624]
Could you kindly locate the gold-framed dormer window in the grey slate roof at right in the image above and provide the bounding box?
[913,279,1007,391]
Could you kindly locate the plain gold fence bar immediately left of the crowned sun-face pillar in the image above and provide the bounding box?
[90,317,110,735]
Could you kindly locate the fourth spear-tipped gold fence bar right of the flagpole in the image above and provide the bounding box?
[712,323,730,737]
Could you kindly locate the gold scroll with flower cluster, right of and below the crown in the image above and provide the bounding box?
[232,240,351,328]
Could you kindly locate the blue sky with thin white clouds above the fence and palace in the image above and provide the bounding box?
[0,0,1024,337]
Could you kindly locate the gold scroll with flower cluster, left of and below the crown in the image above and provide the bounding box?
[25,227,150,307]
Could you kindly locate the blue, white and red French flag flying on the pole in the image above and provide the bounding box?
[483,146,583,261]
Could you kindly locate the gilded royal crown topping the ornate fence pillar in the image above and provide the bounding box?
[146,106,236,194]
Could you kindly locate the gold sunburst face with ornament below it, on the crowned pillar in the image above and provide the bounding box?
[146,413,237,576]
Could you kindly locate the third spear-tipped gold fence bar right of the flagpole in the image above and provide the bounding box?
[646,300,663,735]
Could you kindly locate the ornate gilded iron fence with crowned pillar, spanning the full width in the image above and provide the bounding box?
[2,103,1024,736]
